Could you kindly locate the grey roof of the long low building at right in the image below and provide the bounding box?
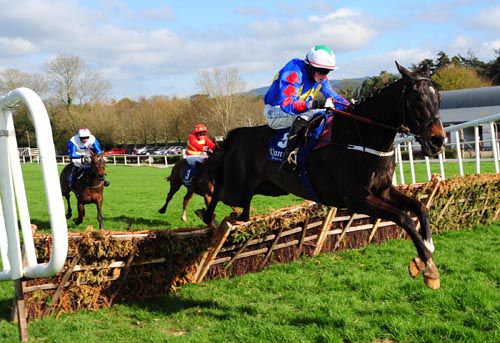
[440,86,500,109]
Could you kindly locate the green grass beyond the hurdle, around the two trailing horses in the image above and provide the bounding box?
[23,164,303,231]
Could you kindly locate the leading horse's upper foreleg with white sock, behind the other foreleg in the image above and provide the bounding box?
[388,187,434,252]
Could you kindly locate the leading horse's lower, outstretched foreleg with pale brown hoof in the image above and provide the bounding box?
[349,194,440,289]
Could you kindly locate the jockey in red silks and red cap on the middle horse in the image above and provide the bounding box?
[184,124,215,185]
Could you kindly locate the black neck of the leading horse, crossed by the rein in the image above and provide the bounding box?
[352,81,403,150]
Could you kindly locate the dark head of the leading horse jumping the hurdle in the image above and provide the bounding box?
[396,62,446,156]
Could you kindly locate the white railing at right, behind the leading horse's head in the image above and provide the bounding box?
[393,113,500,184]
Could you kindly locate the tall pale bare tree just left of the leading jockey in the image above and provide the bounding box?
[197,68,244,135]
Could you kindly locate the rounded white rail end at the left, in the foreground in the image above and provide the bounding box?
[0,88,68,281]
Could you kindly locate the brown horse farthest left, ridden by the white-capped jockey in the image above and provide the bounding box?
[60,153,106,229]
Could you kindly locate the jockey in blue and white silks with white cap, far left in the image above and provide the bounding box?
[68,128,109,188]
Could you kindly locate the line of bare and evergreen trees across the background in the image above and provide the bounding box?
[0,50,500,153]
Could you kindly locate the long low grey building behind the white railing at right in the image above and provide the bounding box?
[439,86,500,149]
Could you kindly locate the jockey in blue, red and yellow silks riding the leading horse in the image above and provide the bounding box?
[264,45,350,171]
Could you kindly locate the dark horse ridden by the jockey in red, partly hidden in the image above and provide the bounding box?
[158,158,214,222]
